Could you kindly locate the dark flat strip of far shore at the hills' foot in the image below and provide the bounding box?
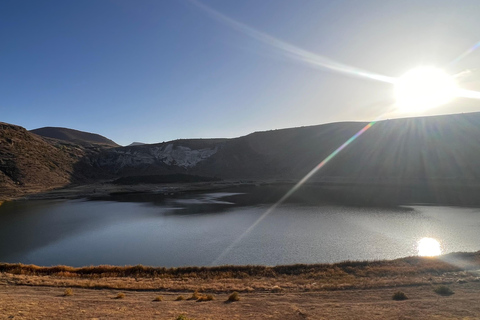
[7,180,480,208]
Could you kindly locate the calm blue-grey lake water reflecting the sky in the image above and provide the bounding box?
[0,187,480,267]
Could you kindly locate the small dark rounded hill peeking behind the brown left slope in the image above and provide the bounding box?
[30,127,119,147]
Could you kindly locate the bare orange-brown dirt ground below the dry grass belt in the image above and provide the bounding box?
[0,281,480,320]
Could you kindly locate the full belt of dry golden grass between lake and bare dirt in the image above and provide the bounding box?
[0,252,480,300]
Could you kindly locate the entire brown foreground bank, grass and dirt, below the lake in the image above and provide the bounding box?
[0,251,480,319]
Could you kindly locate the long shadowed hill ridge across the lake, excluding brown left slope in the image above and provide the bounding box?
[94,113,480,183]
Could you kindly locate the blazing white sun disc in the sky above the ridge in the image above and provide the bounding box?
[395,67,457,112]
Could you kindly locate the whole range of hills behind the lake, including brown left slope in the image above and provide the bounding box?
[0,113,480,204]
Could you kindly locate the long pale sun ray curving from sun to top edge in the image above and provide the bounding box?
[189,0,395,84]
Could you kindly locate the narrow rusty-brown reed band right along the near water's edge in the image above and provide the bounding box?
[0,251,480,279]
